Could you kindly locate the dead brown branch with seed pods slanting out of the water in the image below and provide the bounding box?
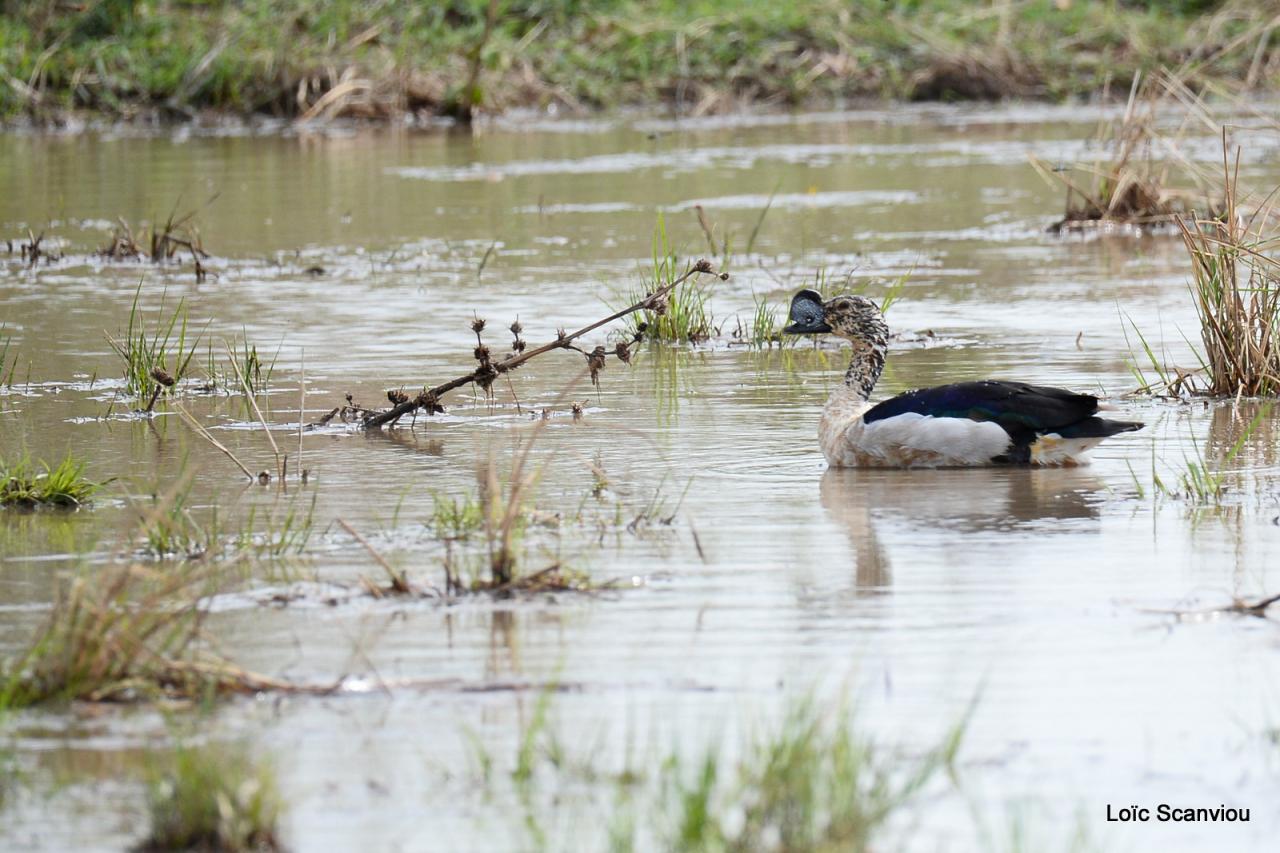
[362,259,728,429]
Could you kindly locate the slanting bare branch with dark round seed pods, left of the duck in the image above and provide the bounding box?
[361,259,728,429]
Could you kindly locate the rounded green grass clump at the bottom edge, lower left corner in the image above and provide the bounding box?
[145,747,284,853]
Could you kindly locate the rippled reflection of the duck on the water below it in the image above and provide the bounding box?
[819,467,1106,594]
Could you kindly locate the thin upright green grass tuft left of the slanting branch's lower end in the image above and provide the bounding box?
[106,282,200,411]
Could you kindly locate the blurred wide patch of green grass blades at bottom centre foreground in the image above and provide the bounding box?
[494,685,966,853]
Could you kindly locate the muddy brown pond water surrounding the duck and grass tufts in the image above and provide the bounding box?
[0,106,1280,850]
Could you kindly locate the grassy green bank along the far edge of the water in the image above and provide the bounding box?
[0,0,1280,119]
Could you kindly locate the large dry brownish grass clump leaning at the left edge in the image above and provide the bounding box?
[0,561,288,708]
